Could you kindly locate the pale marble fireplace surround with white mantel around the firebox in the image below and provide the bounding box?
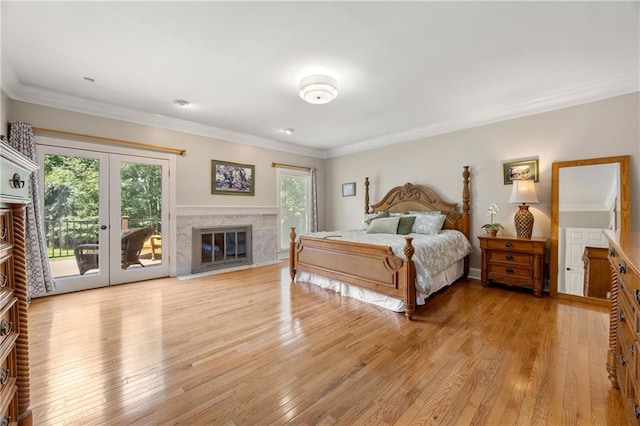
[176,206,278,276]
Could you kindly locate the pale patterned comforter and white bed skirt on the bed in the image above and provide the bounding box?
[296,230,471,312]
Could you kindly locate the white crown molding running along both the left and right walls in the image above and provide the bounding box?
[2,70,640,159]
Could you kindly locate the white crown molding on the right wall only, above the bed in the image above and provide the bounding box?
[326,76,640,158]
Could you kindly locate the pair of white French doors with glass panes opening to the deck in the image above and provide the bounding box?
[38,145,169,294]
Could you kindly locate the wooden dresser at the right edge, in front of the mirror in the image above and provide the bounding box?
[605,231,640,423]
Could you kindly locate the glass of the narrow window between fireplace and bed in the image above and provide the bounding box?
[280,173,309,248]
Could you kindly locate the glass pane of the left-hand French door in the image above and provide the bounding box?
[44,154,100,278]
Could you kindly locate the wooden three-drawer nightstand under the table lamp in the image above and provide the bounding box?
[478,236,547,297]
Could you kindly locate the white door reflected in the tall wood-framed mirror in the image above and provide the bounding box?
[564,228,607,296]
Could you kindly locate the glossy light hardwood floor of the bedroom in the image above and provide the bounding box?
[29,265,626,425]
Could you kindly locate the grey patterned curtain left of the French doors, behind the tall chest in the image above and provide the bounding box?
[9,121,55,301]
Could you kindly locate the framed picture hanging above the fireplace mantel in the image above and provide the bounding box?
[211,160,256,195]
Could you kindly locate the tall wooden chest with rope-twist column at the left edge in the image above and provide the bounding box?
[0,142,37,425]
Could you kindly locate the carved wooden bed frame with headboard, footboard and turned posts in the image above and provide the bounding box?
[289,166,470,319]
